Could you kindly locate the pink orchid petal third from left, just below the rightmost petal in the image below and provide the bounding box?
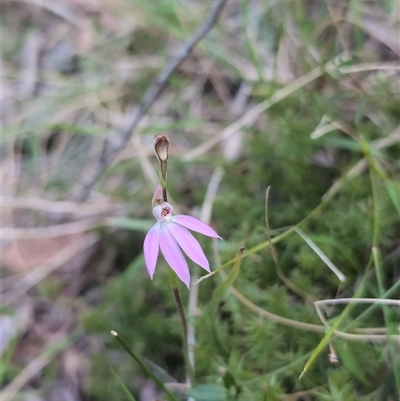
[166,221,210,272]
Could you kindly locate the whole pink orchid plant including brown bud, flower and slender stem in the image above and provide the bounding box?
[143,134,221,383]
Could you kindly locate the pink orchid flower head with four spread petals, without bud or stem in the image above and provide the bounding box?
[143,185,222,288]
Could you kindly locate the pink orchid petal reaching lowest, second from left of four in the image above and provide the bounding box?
[159,223,190,288]
